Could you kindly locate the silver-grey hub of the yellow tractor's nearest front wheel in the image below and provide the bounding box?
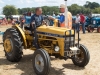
[35,54,44,72]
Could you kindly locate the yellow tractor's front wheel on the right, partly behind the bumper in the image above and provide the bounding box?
[72,44,90,67]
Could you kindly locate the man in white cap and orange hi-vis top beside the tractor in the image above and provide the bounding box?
[59,4,72,29]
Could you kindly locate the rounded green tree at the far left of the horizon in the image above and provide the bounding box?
[3,5,18,16]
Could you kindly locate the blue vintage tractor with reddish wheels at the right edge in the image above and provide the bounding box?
[87,17,100,33]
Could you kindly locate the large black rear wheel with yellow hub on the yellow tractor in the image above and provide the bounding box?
[3,28,23,62]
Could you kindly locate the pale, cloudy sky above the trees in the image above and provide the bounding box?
[0,0,100,12]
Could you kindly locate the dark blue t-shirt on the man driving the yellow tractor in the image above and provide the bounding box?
[31,14,43,26]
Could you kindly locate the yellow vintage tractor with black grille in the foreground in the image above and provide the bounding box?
[3,0,90,75]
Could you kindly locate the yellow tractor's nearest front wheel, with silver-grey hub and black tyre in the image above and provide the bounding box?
[32,49,50,75]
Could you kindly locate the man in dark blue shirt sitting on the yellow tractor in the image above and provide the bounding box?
[31,7,43,49]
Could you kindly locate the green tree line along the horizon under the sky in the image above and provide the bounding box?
[3,1,100,16]
